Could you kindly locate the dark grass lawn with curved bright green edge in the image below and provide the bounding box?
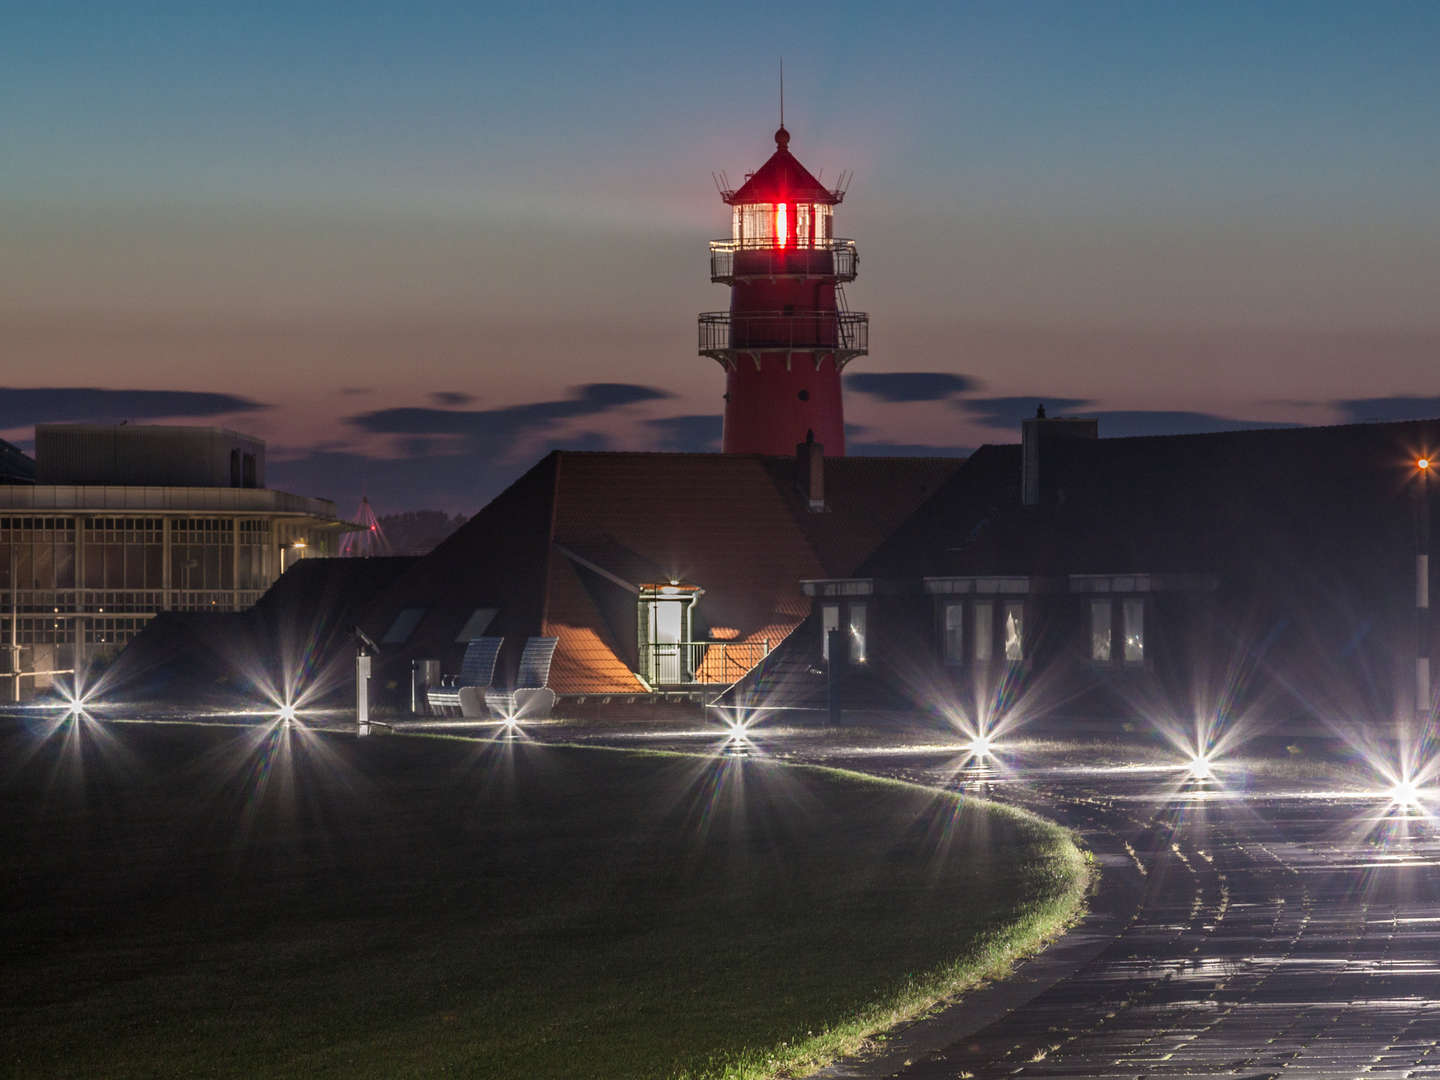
[0,721,1086,1080]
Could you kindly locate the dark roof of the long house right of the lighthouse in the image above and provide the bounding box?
[857,420,1440,593]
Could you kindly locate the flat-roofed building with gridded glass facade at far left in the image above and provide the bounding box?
[0,423,353,700]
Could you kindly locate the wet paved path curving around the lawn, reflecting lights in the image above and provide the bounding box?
[541,729,1440,1080]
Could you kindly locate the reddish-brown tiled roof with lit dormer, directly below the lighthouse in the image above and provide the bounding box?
[366,451,960,694]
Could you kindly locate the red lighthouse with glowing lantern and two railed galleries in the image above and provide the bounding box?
[700,127,870,455]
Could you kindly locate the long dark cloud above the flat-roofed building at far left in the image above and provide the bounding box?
[0,386,271,431]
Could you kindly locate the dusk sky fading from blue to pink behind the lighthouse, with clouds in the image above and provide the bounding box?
[8,0,1440,513]
